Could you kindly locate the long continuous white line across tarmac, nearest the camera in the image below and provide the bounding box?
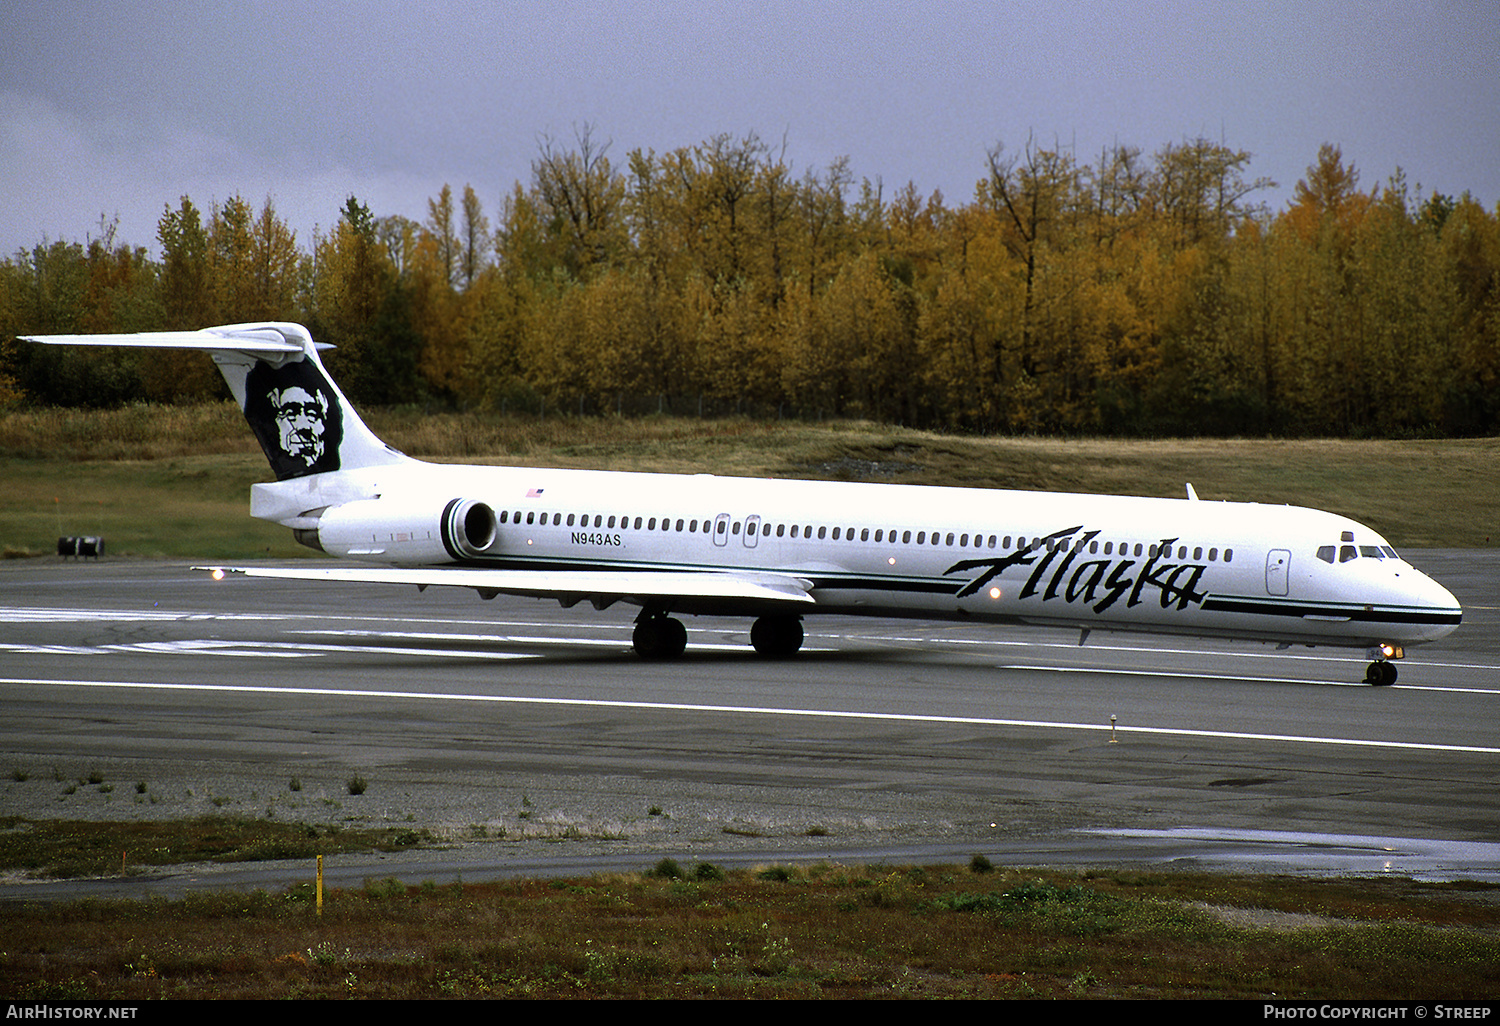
[0,677,1500,755]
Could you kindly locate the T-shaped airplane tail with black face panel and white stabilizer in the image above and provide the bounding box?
[23,321,408,480]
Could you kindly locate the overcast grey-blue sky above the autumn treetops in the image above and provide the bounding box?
[0,0,1500,255]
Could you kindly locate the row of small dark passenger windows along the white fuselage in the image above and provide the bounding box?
[500,510,1236,563]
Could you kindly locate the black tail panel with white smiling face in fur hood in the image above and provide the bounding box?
[245,360,344,480]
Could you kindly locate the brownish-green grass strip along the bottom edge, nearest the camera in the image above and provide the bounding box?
[0,860,1500,1001]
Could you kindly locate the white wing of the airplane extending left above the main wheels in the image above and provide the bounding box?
[194,567,815,609]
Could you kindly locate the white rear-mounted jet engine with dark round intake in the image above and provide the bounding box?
[296,498,500,564]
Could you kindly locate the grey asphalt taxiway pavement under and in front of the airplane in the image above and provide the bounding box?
[0,551,1500,899]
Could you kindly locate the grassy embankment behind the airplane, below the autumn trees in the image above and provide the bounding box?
[0,404,1500,560]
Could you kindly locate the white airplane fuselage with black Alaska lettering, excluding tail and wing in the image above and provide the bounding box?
[252,461,1461,648]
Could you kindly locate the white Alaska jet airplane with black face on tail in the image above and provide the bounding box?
[23,321,1463,686]
